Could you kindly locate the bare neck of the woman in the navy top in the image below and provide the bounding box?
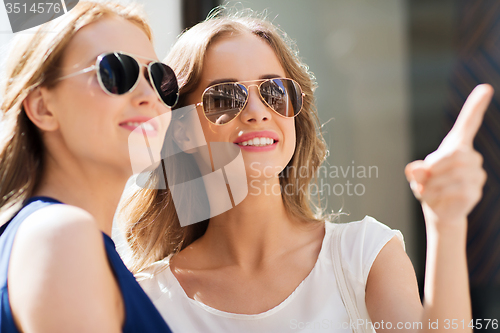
[34,155,128,236]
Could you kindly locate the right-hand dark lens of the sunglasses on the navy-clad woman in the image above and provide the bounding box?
[150,62,179,107]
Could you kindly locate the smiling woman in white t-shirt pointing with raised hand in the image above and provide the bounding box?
[124,7,492,333]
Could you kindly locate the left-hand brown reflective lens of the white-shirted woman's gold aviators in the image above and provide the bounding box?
[203,83,248,125]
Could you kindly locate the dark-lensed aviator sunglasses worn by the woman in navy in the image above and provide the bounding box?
[58,51,179,108]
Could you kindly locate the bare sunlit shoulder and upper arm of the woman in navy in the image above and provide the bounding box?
[8,204,121,332]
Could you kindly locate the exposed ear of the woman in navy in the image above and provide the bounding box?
[23,87,59,132]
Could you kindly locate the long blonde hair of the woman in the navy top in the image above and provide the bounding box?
[0,1,152,223]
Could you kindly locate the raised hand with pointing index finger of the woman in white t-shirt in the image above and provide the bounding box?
[405,84,493,225]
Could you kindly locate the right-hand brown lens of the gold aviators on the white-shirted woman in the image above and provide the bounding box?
[260,79,302,117]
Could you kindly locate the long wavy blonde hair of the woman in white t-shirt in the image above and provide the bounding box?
[120,8,326,272]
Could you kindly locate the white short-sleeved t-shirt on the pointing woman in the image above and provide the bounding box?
[136,216,403,333]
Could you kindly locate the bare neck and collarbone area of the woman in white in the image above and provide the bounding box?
[200,176,317,266]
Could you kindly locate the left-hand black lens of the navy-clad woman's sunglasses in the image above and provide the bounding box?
[99,53,140,95]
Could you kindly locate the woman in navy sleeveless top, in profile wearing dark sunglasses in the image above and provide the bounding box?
[0,1,178,333]
